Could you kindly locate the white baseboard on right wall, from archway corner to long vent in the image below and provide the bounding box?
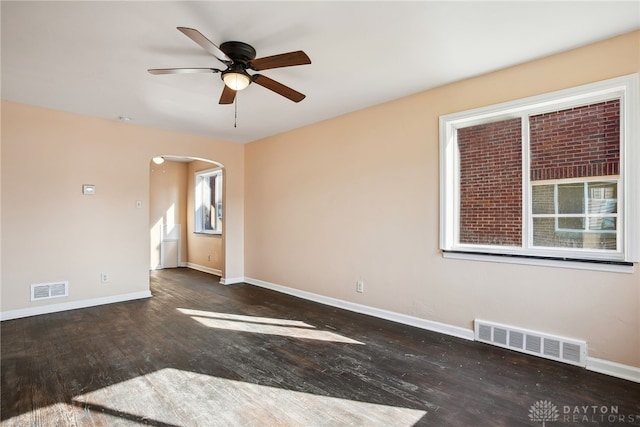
[244,277,474,341]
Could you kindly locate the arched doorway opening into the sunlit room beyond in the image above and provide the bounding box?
[149,155,225,277]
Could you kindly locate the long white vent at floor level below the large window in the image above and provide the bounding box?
[474,319,587,367]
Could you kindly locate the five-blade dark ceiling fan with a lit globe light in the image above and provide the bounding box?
[147,27,311,104]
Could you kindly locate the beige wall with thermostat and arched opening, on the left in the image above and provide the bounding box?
[0,102,244,313]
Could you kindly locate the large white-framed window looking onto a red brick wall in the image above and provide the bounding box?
[440,75,640,264]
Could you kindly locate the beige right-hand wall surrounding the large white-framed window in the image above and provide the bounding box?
[245,32,640,367]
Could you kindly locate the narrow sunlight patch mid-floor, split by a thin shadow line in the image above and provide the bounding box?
[178,308,364,344]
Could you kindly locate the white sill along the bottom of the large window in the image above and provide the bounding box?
[442,251,634,274]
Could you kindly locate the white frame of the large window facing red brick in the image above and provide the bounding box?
[439,73,640,271]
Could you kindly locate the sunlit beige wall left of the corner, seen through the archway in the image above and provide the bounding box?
[149,161,189,269]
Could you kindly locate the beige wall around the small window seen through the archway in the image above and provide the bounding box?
[187,161,226,271]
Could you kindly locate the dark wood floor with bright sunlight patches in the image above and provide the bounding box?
[1,269,640,426]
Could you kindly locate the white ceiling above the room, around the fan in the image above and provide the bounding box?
[1,0,640,142]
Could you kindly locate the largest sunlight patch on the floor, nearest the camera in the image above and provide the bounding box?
[73,368,426,427]
